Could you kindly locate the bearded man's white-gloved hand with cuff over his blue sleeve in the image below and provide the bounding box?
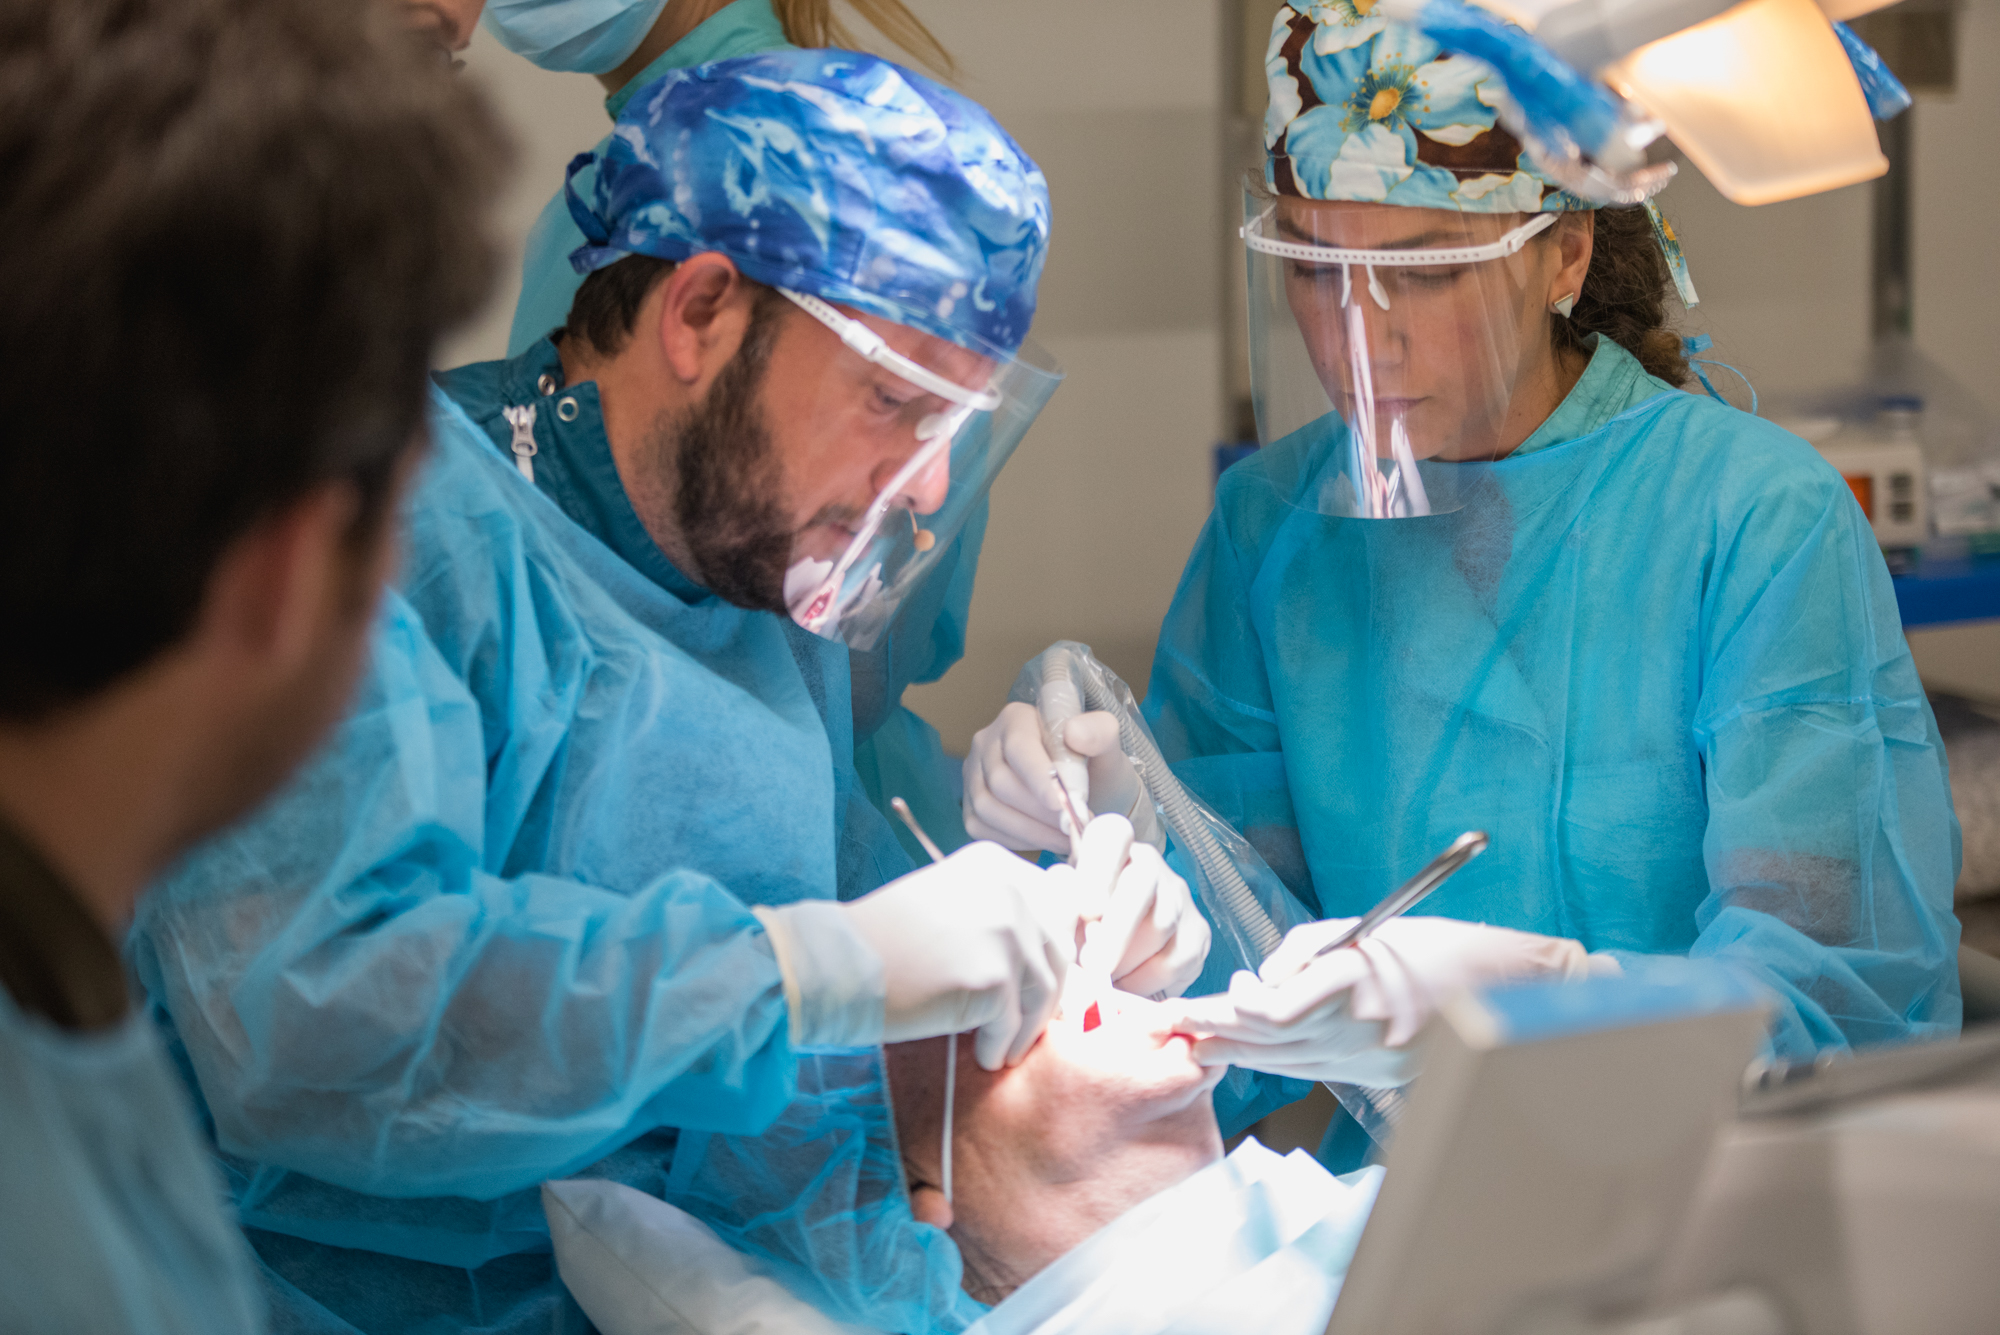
[752,843,1078,1071]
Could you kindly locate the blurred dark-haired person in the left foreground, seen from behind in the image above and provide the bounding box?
[0,0,504,1333]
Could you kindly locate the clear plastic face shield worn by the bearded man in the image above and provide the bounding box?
[782,290,1062,652]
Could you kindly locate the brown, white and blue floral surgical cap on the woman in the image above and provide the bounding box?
[1264,0,1592,214]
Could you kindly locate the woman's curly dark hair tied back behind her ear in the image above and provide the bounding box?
[1548,208,1688,386]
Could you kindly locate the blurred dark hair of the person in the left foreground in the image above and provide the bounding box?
[0,0,508,721]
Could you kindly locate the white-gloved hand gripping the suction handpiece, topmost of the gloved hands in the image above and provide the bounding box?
[966,701,1158,855]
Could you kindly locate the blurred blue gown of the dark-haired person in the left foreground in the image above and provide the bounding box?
[0,987,264,1335]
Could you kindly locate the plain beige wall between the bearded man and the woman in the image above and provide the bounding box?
[910,0,1224,747]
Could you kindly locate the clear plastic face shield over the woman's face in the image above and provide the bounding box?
[1242,190,1562,520]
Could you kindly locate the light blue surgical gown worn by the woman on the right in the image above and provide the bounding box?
[1146,340,1960,1057]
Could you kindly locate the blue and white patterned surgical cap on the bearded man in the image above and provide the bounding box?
[568,50,1048,354]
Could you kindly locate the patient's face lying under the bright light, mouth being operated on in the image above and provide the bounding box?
[888,997,1226,1303]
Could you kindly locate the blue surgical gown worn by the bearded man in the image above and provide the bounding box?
[132,377,964,1333]
